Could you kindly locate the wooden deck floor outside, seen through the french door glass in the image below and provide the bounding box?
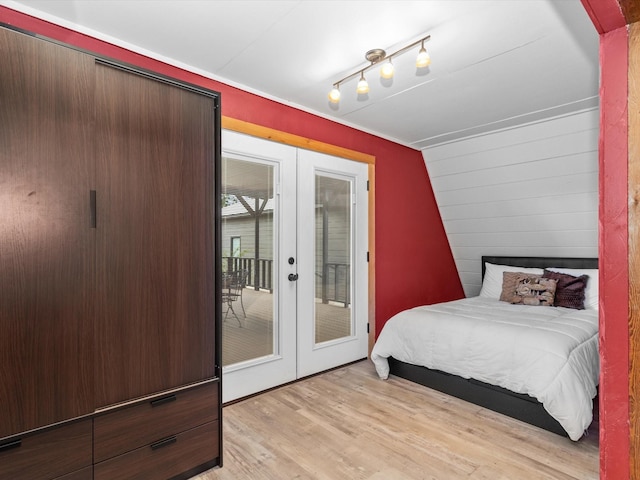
[222,288,351,366]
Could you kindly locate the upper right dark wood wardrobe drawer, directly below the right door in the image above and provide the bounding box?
[93,382,218,463]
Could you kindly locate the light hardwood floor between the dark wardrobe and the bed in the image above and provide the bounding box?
[194,360,599,480]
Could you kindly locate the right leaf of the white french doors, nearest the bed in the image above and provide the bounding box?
[297,150,368,377]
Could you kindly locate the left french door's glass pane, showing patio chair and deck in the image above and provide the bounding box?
[222,157,277,366]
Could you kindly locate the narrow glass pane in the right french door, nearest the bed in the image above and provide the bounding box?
[314,174,353,343]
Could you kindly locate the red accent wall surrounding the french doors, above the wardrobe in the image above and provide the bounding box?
[0,6,464,338]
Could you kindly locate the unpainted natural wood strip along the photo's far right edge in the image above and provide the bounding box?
[628,19,640,480]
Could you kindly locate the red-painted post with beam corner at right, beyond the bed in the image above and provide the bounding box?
[582,0,630,480]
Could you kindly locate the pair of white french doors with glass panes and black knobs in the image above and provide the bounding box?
[222,131,368,402]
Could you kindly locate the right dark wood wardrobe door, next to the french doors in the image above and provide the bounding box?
[95,63,216,407]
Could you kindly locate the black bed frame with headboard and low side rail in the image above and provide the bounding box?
[389,256,598,436]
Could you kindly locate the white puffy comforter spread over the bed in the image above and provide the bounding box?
[371,297,600,440]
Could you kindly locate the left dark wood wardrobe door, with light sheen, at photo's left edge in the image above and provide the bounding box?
[0,28,95,438]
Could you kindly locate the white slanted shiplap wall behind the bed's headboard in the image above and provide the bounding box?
[423,109,599,296]
